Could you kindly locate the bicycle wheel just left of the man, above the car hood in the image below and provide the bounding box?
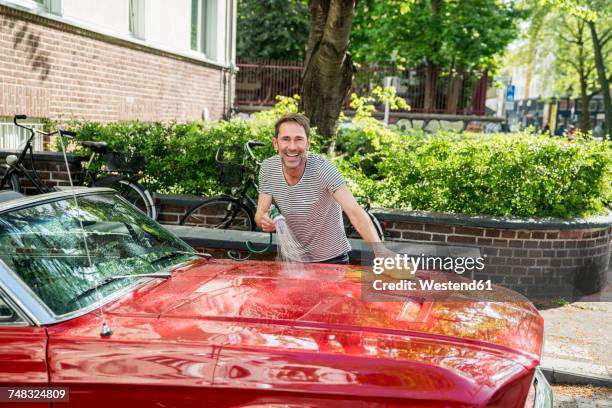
[181,197,255,231]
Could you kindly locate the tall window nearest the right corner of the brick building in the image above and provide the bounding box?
[191,0,220,60]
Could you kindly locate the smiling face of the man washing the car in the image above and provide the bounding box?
[272,122,310,169]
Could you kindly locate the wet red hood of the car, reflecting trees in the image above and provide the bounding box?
[108,260,543,357]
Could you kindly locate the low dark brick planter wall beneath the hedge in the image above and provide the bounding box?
[158,196,612,300]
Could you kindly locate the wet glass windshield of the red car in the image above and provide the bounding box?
[0,194,193,315]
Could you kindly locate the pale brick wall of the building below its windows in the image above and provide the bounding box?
[0,6,227,122]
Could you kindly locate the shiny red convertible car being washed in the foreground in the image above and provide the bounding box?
[0,189,552,408]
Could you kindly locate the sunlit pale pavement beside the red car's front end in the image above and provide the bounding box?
[540,271,612,385]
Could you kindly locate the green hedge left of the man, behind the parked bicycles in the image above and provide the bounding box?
[62,97,318,196]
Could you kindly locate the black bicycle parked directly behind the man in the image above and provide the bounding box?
[180,140,384,241]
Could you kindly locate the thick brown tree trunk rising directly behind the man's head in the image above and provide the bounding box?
[301,0,355,149]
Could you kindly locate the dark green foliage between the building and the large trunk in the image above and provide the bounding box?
[236,0,308,61]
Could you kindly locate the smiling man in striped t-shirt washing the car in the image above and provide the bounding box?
[255,113,382,264]
